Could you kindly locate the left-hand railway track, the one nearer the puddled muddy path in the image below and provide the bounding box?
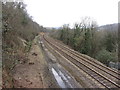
[43,34,120,88]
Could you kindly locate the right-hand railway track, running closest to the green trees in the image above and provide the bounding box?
[45,35,120,81]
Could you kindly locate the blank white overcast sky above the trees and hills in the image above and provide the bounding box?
[24,0,120,27]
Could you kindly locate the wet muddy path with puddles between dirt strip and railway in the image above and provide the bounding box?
[38,35,82,88]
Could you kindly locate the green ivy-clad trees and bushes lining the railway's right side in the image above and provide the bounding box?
[51,17,118,66]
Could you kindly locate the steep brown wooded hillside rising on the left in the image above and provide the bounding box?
[2,2,44,87]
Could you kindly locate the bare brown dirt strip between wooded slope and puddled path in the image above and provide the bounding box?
[13,35,58,88]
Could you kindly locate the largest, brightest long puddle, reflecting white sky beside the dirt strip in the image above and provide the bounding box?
[52,68,66,88]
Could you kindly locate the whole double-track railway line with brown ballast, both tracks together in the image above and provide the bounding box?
[43,35,120,88]
